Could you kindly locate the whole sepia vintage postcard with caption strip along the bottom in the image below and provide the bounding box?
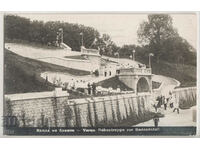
[2,12,198,137]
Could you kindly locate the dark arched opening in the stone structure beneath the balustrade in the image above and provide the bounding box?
[136,77,150,93]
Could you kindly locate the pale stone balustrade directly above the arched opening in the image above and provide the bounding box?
[120,68,151,75]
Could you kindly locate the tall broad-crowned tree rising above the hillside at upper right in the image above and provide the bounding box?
[138,14,178,63]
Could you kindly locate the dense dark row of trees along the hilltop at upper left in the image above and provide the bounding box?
[4,15,100,51]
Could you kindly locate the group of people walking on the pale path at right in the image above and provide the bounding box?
[153,92,180,127]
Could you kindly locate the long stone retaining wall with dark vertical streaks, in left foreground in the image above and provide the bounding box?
[5,93,153,127]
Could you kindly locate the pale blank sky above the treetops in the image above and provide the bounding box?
[17,13,197,49]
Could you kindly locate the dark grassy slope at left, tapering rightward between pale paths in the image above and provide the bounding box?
[4,50,89,94]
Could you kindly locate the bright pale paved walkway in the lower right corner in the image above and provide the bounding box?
[136,106,196,127]
